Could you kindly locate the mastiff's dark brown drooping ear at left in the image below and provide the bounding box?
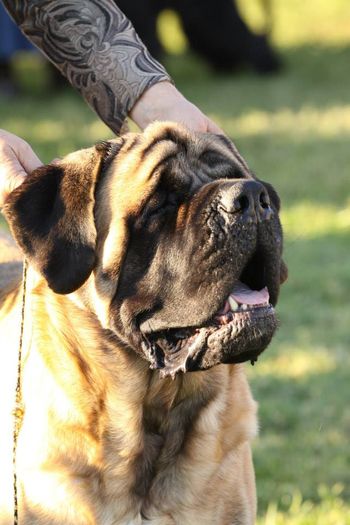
[4,148,107,294]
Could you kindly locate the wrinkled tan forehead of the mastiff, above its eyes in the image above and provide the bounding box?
[97,123,251,216]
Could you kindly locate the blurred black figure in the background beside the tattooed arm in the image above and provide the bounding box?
[116,0,280,74]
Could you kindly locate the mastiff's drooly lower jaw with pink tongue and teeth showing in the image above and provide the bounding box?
[143,281,277,377]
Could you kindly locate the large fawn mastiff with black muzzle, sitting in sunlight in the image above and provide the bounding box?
[0,123,286,525]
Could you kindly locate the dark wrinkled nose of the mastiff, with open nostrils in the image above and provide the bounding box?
[221,180,272,223]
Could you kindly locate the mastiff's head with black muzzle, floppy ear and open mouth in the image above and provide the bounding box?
[5,123,286,375]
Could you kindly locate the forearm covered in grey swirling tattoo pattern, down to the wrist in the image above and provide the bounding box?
[3,0,169,132]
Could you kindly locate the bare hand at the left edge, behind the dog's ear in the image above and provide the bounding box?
[0,129,42,208]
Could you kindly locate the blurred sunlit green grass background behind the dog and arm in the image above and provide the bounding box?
[0,0,350,525]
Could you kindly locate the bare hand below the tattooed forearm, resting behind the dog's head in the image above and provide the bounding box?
[130,82,224,135]
